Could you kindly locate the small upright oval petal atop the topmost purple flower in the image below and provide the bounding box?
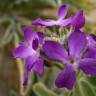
[58,5,68,19]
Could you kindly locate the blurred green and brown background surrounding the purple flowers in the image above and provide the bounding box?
[0,0,96,96]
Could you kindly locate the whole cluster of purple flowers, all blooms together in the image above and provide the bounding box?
[13,5,96,90]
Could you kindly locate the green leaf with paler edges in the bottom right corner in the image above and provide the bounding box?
[74,76,96,96]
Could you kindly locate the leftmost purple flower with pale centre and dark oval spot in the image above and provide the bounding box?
[13,27,44,85]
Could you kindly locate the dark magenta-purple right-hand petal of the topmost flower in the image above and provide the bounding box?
[72,10,85,29]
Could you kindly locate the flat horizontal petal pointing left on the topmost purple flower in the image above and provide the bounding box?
[32,19,55,26]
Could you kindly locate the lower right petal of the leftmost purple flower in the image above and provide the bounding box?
[32,58,44,75]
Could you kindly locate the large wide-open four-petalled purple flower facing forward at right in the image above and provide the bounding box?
[43,31,96,90]
